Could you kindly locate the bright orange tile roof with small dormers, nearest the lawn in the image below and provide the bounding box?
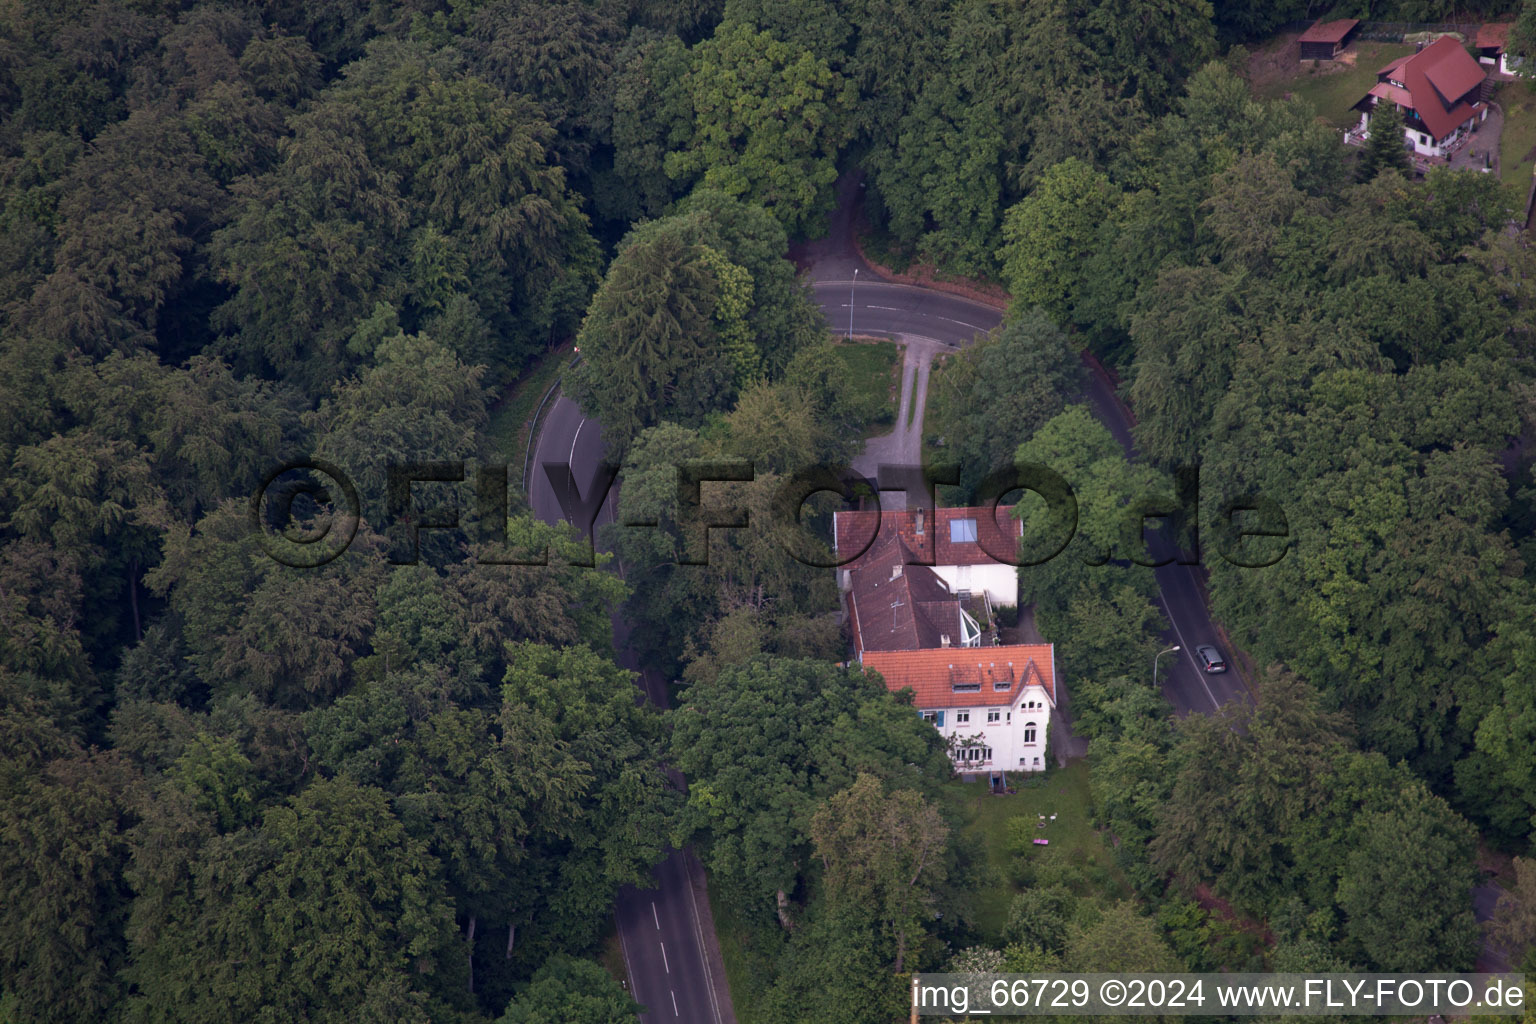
[863,643,1055,709]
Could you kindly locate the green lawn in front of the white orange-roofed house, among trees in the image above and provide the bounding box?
[945,760,1130,943]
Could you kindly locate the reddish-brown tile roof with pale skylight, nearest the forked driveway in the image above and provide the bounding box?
[833,505,1025,570]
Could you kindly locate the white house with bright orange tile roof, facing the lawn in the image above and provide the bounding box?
[863,643,1057,772]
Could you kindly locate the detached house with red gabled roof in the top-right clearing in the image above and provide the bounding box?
[1355,35,1488,157]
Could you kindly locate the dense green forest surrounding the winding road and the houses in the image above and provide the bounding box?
[0,0,1536,1024]
